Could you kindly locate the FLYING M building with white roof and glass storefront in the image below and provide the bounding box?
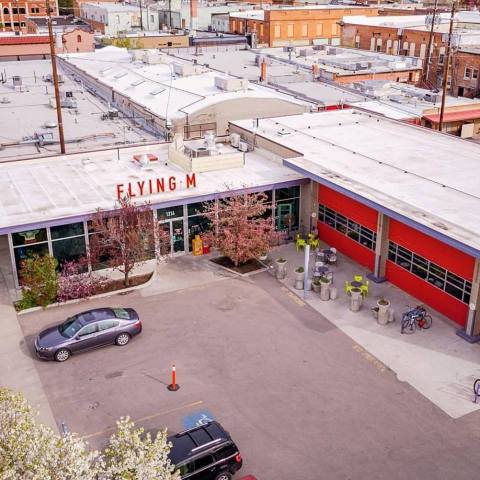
[0,136,309,288]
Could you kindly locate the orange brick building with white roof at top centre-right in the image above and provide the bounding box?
[230,5,378,47]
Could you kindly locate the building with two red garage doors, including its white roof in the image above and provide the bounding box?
[231,110,480,338]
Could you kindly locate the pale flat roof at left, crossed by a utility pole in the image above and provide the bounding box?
[0,60,155,161]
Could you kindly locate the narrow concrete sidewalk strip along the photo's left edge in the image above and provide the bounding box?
[0,238,58,431]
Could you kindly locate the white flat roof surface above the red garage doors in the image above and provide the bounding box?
[231,110,480,256]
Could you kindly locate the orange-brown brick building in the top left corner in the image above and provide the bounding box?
[0,0,58,32]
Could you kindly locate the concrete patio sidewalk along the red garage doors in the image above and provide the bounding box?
[272,244,480,418]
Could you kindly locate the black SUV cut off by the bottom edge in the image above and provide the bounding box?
[168,422,242,480]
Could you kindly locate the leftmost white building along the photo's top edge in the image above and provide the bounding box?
[81,3,141,37]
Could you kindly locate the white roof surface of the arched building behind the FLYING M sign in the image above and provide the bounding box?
[62,46,304,124]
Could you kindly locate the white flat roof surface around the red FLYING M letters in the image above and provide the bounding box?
[0,142,305,233]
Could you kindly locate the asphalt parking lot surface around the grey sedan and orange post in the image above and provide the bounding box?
[19,274,480,480]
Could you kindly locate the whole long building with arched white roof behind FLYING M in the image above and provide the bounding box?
[60,47,311,138]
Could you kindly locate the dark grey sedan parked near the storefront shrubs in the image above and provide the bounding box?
[35,308,142,362]
